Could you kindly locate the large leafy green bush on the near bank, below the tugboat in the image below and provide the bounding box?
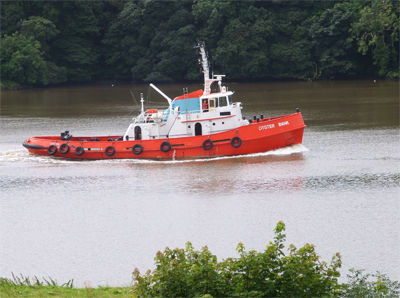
[133,222,341,297]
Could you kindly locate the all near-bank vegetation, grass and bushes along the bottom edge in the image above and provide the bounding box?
[0,221,400,298]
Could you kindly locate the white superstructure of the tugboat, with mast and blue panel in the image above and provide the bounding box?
[124,43,249,140]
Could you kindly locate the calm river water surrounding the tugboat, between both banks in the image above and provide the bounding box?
[0,80,400,286]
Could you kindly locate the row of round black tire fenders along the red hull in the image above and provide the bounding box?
[47,137,242,156]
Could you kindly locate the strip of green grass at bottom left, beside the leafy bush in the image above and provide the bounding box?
[0,274,133,298]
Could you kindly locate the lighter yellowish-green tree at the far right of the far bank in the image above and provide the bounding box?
[351,0,400,77]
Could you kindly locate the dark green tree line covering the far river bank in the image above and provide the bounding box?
[0,0,400,85]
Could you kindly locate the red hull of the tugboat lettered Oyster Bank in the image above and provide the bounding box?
[23,113,305,160]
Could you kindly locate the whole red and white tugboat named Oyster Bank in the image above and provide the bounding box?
[23,42,306,160]
